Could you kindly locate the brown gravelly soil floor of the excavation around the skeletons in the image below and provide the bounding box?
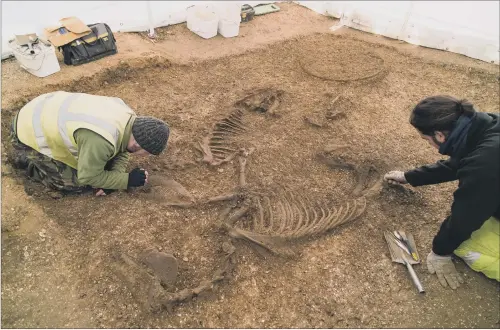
[2,3,500,328]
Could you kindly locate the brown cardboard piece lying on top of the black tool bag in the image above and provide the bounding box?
[44,17,92,47]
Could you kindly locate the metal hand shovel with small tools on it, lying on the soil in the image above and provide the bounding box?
[384,231,425,293]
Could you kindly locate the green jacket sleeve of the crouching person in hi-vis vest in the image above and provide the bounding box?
[75,129,128,189]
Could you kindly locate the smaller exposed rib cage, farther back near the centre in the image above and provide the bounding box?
[199,109,246,166]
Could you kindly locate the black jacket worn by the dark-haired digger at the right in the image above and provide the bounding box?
[405,112,500,255]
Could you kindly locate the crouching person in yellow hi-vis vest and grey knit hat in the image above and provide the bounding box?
[12,91,169,196]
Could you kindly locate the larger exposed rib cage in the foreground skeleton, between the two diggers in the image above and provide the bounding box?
[227,188,366,254]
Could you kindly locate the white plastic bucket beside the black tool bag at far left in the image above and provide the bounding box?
[9,39,61,77]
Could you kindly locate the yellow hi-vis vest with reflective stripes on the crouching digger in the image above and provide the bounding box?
[17,91,135,169]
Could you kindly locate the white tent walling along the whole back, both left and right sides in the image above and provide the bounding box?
[2,1,500,64]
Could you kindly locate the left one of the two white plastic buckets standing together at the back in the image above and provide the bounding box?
[186,5,219,39]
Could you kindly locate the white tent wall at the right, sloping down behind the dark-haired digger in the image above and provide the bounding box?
[297,1,500,64]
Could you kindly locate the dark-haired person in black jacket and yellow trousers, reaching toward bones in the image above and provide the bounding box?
[384,95,500,289]
